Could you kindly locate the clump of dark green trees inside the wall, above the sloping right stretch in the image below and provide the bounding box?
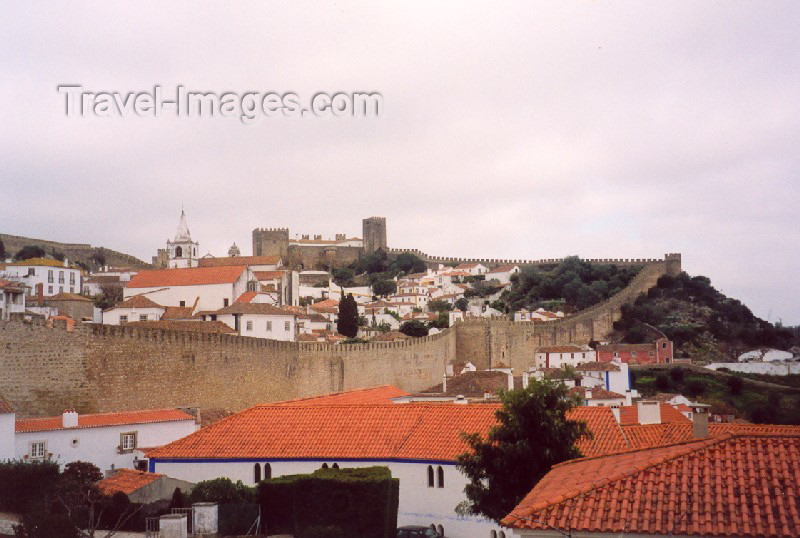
[500,256,641,312]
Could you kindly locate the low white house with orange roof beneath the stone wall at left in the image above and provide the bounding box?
[12,409,198,471]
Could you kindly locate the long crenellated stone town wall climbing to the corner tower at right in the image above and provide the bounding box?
[0,255,680,417]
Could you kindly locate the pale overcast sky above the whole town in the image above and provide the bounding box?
[0,1,800,324]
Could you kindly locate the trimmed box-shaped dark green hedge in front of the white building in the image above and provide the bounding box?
[258,467,400,538]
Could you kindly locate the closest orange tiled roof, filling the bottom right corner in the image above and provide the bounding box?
[502,433,800,537]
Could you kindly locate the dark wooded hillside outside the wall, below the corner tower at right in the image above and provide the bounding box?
[614,273,798,362]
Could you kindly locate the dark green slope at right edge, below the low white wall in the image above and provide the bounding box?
[632,366,800,424]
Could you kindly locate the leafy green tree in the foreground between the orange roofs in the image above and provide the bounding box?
[456,379,591,521]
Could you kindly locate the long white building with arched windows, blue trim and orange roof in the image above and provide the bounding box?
[148,402,500,538]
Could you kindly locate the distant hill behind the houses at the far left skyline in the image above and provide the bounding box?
[0,234,150,269]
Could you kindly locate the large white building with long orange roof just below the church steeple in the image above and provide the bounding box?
[123,265,257,311]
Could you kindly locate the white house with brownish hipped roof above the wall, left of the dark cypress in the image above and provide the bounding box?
[208,303,299,342]
